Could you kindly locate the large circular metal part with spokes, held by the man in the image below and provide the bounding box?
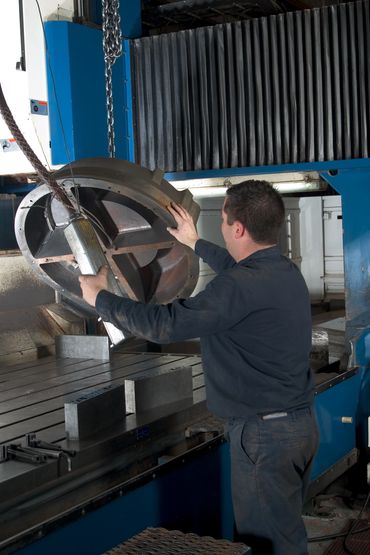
[15,158,199,312]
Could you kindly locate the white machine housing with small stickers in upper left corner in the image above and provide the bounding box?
[0,0,74,175]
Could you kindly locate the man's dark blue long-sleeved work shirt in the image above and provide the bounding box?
[96,239,312,418]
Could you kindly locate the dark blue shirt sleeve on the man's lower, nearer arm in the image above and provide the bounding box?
[96,273,248,343]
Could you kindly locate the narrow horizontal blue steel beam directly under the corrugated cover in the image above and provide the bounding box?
[164,158,370,181]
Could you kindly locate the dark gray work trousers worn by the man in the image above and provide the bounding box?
[225,408,318,555]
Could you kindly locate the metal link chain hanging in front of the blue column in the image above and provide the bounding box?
[102,0,122,158]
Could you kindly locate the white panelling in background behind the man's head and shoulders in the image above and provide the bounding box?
[194,191,344,303]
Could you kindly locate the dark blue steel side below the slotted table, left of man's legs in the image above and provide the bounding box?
[17,444,233,555]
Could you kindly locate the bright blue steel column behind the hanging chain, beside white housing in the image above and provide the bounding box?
[45,21,133,164]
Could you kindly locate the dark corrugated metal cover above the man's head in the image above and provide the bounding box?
[132,1,370,171]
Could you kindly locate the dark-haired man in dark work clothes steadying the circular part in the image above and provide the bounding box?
[80,181,317,555]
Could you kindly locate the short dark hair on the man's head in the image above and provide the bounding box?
[224,180,285,245]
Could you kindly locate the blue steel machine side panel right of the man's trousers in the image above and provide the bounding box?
[311,374,361,480]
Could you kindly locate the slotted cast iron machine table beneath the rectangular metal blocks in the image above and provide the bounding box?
[0,350,208,552]
